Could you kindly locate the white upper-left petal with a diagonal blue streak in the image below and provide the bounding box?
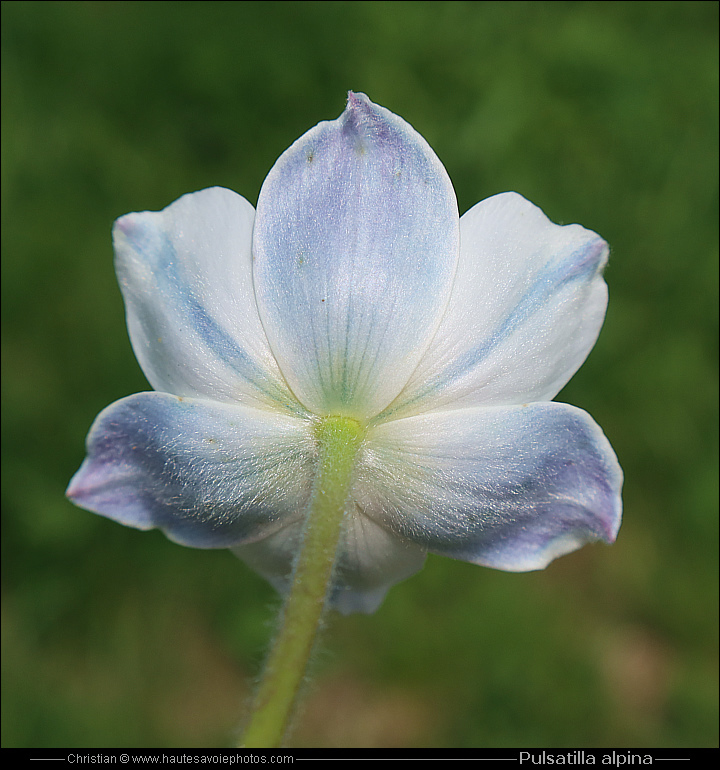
[113,187,294,412]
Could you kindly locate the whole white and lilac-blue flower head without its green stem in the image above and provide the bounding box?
[67,93,622,613]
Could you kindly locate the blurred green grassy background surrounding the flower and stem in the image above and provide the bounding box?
[2,2,718,748]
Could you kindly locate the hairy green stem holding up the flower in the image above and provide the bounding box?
[242,417,365,748]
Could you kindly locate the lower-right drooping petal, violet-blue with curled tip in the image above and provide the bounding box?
[356,403,622,571]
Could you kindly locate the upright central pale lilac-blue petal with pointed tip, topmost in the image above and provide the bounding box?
[253,94,459,418]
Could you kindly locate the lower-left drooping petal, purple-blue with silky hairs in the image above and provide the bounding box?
[67,393,315,548]
